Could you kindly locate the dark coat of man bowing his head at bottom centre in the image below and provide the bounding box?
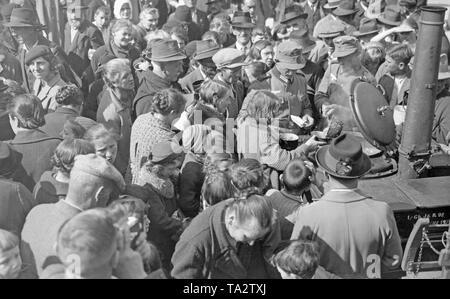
[171,201,280,279]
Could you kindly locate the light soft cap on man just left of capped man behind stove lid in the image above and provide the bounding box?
[274,40,306,70]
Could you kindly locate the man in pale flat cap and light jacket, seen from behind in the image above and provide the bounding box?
[20,154,125,279]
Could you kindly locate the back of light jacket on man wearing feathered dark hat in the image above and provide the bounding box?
[291,190,402,278]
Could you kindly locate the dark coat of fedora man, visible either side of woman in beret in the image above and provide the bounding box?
[17,36,80,93]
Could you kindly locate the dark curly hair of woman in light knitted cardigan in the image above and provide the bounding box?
[151,88,186,115]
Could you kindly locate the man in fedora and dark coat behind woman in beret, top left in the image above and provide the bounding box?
[5,8,79,92]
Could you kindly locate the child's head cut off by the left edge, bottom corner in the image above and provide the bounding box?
[0,229,22,279]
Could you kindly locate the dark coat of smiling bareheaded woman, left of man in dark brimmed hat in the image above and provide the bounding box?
[91,42,140,74]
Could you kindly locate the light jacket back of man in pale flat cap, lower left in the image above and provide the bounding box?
[21,200,81,278]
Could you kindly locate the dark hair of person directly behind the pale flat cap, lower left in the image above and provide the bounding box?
[51,139,95,176]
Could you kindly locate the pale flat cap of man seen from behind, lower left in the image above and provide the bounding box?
[72,154,125,190]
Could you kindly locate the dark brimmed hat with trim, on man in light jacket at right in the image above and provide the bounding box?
[316,134,372,179]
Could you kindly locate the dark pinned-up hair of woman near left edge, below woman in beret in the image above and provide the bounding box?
[7,94,45,130]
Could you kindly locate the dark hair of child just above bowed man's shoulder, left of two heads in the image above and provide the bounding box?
[202,171,234,206]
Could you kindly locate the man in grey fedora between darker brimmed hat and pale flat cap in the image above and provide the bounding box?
[179,40,220,93]
